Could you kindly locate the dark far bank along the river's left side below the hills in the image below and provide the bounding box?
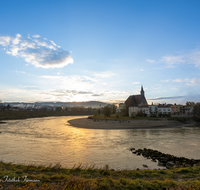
[0,111,93,120]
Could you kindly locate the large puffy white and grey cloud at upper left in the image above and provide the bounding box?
[0,34,74,68]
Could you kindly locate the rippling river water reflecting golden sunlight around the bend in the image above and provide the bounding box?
[0,116,200,170]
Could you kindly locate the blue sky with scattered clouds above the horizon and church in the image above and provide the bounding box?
[0,0,200,104]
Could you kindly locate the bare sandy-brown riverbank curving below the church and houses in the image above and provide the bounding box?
[68,118,194,130]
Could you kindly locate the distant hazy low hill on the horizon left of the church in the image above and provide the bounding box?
[3,101,108,108]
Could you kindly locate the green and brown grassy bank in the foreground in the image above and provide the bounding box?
[0,162,200,190]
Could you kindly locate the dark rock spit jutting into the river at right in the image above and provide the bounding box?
[129,148,200,169]
